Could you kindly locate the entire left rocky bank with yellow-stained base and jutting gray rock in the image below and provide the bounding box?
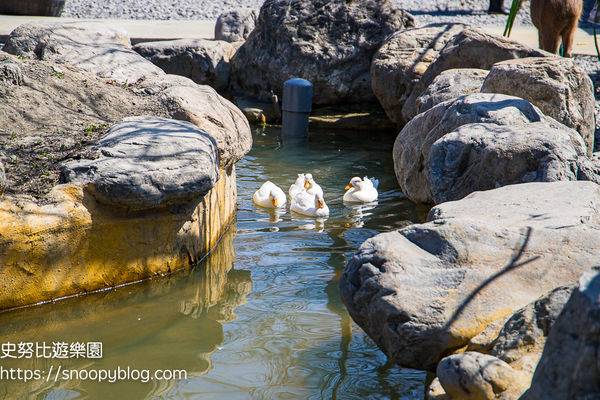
[0,43,251,309]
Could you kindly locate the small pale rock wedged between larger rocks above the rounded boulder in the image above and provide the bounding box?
[416,68,488,114]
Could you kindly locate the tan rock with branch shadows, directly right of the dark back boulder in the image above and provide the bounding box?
[371,24,464,125]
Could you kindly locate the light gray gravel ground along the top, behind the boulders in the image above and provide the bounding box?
[63,0,594,27]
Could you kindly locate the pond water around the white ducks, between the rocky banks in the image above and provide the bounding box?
[0,129,425,400]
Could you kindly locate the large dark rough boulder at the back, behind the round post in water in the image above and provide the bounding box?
[231,0,415,104]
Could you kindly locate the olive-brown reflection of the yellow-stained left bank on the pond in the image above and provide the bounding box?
[0,226,252,399]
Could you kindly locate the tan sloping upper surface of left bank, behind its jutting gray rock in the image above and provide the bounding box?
[0,51,252,196]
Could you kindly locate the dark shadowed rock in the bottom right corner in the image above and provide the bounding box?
[521,270,600,400]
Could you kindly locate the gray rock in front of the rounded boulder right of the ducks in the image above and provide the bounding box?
[423,122,600,204]
